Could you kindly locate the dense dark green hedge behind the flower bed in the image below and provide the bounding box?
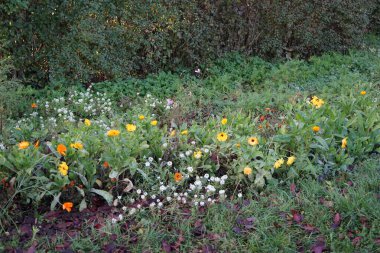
[0,0,379,86]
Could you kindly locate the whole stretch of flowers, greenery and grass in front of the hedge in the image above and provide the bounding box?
[0,35,380,252]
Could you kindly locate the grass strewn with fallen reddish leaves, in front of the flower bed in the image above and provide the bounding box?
[0,156,380,252]
